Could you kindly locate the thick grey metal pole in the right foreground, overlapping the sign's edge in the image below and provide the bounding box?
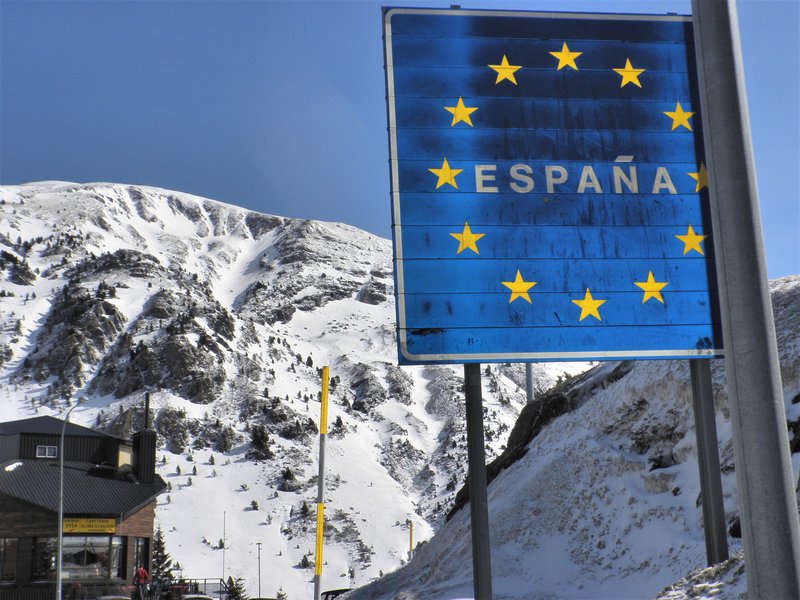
[692,0,800,600]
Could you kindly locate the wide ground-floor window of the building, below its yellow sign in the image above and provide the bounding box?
[33,535,122,581]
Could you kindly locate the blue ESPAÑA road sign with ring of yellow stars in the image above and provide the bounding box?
[384,8,722,364]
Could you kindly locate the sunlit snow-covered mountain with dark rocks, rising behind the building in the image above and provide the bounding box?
[0,182,587,598]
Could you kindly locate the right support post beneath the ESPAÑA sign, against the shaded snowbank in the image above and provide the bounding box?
[689,359,728,566]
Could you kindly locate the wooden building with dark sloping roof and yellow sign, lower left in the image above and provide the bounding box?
[0,417,167,600]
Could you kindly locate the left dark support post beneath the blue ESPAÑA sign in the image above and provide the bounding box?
[464,363,492,600]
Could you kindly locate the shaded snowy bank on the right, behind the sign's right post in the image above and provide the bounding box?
[348,276,800,600]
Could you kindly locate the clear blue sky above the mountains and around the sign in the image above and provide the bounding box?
[0,0,800,277]
